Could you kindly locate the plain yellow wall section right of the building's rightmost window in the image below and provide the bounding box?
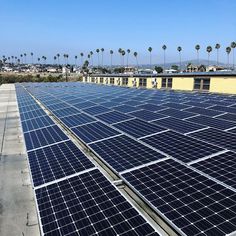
[210,77,236,94]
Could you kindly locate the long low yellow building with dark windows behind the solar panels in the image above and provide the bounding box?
[83,72,236,94]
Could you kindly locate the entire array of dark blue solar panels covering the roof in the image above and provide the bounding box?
[17,83,236,236]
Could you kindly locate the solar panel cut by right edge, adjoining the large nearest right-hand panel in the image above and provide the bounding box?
[191,151,236,192]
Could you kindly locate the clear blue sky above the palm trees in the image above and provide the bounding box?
[0,0,236,64]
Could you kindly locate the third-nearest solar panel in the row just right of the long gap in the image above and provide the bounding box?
[71,122,119,143]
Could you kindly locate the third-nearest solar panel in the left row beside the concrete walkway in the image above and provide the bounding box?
[24,125,68,151]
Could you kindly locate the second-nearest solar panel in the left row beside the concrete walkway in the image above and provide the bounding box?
[28,141,94,186]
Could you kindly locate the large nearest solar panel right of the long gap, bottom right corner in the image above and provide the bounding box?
[122,159,236,236]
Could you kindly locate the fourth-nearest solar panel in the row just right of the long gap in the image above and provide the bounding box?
[60,113,96,128]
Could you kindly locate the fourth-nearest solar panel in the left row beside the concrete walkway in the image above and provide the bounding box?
[21,116,55,133]
